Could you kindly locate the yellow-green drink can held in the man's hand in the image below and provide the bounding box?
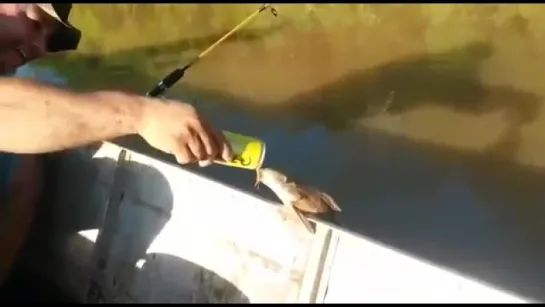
[216,131,265,170]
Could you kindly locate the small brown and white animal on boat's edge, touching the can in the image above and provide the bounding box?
[255,168,341,234]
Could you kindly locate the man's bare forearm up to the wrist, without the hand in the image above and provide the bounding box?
[0,78,144,153]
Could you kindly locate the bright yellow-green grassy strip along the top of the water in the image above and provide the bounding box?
[63,4,545,53]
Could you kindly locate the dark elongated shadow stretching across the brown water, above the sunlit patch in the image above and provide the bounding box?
[281,43,539,147]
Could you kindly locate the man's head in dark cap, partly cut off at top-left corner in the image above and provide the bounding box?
[0,3,81,73]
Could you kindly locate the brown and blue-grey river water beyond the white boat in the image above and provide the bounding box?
[21,4,545,300]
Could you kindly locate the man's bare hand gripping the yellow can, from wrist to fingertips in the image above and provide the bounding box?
[138,98,233,166]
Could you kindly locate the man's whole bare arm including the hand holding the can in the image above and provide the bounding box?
[0,78,232,165]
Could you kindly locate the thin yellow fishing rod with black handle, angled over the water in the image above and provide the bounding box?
[146,3,278,97]
